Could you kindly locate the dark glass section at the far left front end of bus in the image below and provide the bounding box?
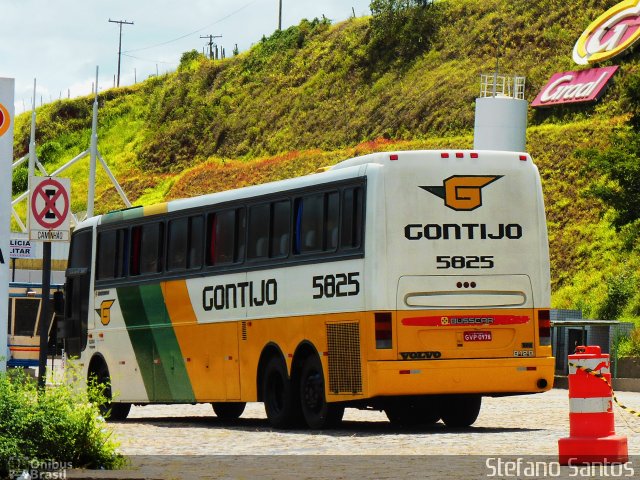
[58,228,93,356]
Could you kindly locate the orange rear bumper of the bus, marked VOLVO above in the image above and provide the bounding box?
[368,357,555,397]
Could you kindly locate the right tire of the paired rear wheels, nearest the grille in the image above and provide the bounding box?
[300,355,344,429]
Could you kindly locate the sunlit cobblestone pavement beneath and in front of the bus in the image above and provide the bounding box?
[69,389,640,478]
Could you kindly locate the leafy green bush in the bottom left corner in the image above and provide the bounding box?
[0,370,124,478]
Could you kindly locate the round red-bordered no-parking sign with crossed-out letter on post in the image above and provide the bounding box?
[31,178,69,230]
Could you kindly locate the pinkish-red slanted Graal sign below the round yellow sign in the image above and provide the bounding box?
[531,66,618,107]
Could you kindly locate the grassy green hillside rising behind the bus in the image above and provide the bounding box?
[8,0,640,326]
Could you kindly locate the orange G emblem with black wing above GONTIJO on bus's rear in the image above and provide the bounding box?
[420,175,502,211]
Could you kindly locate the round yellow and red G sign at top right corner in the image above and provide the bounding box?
[573,0,640,65]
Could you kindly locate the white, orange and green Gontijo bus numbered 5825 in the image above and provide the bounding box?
[61,151,554,428]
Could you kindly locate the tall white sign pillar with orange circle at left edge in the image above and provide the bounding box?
[0,78,15,371]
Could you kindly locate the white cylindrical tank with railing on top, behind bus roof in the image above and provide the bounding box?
[473,73,529,152]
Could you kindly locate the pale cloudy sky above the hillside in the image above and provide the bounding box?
[0,0,370,114]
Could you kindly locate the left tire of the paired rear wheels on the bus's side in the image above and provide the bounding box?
[262,357,300,428]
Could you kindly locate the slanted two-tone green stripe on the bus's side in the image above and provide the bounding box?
[117,285,195,402]
